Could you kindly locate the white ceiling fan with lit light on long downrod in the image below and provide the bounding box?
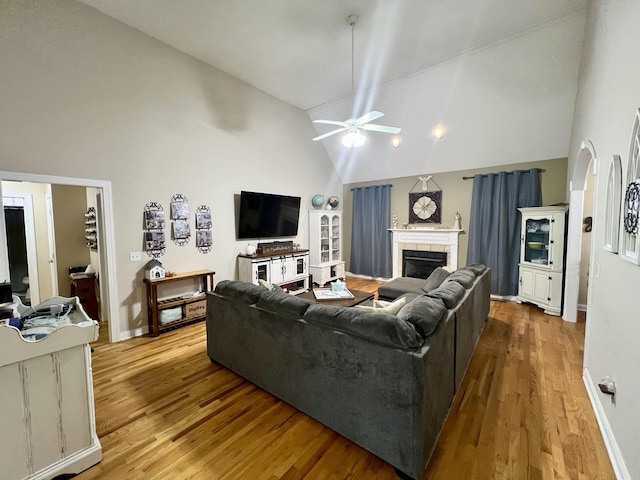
[313,15,401,147]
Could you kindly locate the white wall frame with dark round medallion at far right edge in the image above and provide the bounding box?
[620,109,640,265]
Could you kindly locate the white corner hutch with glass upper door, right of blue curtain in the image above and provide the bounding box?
[518,206,567,315]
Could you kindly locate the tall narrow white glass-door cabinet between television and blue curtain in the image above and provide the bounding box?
[309,210,345,287]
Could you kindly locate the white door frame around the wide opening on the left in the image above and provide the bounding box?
[0,171,120,342]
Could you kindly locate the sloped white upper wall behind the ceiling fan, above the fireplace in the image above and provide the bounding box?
[309,14,585,183]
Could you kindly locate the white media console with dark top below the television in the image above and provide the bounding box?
[238,250,309,294]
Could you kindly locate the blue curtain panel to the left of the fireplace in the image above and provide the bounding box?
[349,185,391,278]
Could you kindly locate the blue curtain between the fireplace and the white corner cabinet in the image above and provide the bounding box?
[467,168,542,296]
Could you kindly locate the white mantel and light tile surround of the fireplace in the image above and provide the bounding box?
[389,228,464,278]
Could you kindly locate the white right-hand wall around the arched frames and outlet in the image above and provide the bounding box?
[569,0,640,478]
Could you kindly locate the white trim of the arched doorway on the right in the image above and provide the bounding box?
[562,140,598,323]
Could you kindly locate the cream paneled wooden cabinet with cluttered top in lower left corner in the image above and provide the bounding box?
[0,297,102,480]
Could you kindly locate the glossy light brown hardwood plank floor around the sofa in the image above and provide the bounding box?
[81,278,615,480]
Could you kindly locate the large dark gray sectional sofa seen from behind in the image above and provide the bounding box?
[206,268,490,479]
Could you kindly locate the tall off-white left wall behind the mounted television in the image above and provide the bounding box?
[0,0,341,334]
